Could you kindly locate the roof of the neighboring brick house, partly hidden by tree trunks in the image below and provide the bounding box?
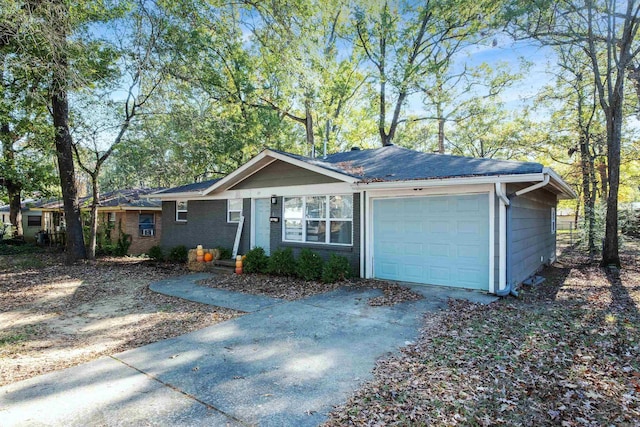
[39,188,162,210]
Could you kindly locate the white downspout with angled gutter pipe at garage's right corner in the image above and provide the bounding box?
[495,172,553,297]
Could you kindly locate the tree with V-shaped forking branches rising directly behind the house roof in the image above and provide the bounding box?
[354,0,495,145]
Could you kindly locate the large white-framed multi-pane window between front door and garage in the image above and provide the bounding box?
[282,194,353,245]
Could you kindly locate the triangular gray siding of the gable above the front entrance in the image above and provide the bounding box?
[231,160,340,190]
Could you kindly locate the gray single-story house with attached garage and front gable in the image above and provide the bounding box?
[153,145,575,294]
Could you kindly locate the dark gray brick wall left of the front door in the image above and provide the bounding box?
[161,199,251,253]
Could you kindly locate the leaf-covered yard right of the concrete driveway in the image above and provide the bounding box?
[327,240,640,426]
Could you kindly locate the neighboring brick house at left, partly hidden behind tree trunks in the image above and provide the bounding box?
[39,188,162,254]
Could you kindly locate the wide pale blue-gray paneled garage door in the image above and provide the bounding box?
[373,194,489,290]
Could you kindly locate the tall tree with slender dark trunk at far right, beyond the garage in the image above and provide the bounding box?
[505,0,640,267]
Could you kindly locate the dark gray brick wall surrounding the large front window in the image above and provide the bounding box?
[271,193,361,277]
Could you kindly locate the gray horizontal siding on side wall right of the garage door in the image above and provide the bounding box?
[507,185,557,284]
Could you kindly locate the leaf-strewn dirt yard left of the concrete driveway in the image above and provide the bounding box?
[0,253,242,386]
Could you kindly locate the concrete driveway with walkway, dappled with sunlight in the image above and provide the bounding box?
[0,276,495,426]
